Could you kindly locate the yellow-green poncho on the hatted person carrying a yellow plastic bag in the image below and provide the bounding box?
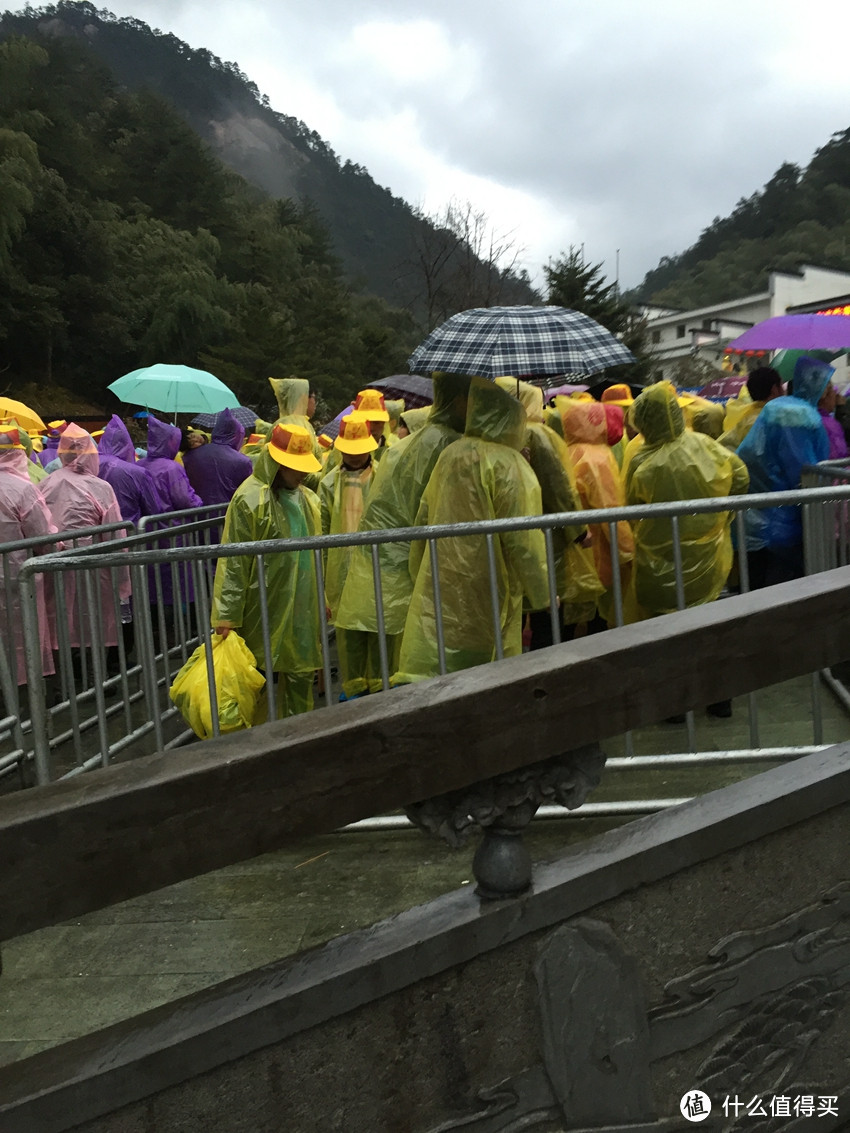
[211,449,322,670]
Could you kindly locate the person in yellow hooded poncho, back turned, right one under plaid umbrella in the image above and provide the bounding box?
[393,377,549,684]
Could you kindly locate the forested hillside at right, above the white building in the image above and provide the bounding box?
[635,129,850,308]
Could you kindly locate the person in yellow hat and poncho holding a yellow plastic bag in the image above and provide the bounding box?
[211,425,322,723]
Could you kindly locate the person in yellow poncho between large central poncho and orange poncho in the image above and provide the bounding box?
[495,377,602,649]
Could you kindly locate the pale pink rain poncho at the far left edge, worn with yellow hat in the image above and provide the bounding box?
[0,433,61,684]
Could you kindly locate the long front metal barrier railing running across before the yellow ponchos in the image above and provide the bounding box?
[11,484,850,788]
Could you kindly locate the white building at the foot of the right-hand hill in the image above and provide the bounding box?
[643,264,850,377]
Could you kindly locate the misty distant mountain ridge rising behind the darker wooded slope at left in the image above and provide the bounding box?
[0,2,534,317]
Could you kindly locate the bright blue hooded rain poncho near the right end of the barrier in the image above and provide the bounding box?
[738,358,832,551]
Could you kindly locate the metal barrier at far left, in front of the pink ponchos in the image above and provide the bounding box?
[0,505,226,784]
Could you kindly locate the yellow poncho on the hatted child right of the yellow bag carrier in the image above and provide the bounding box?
[318,450,378,699]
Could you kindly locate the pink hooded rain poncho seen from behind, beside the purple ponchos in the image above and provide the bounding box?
[42,425,130,648]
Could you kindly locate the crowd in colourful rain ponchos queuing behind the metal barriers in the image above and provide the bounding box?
[0,358,847,716]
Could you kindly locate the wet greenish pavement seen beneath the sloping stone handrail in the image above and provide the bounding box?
[0,678,850,1063]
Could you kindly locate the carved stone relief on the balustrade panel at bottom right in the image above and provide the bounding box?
[419,884,850,1133]
